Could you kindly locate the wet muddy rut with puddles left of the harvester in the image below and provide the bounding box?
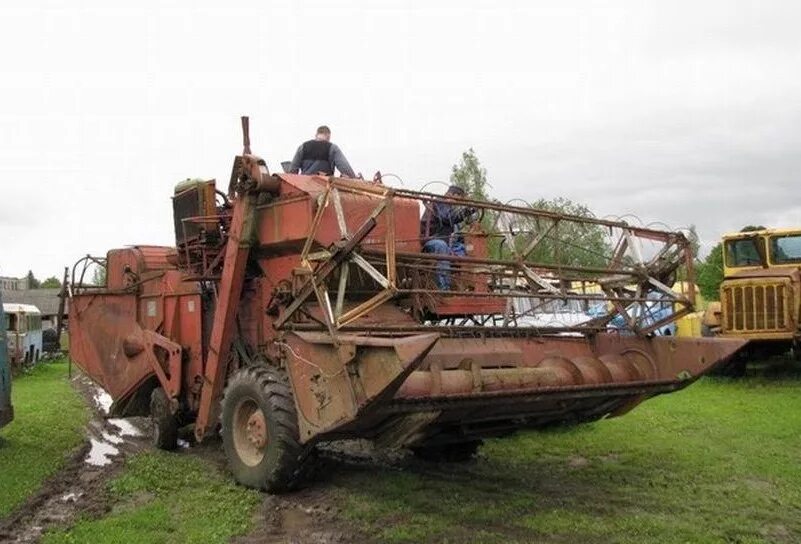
[0,374,150,544]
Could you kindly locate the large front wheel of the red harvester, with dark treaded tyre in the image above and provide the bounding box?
[222,365,303,493]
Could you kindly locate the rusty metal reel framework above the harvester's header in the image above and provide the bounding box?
[260,178,694,336]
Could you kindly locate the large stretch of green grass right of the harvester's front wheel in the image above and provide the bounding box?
[332,368,801,543]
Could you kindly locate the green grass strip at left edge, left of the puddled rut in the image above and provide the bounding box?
[0,361,89,517]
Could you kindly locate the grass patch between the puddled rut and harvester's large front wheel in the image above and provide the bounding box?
[42,451,262,544]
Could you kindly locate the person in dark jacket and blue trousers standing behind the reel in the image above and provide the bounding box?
[420,185,476,290]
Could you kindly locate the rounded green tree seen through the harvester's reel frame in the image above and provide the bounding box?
[521,197,612,267]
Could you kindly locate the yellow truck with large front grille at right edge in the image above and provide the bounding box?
[704,228,801,374]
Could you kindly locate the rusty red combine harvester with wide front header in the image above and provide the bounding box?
[69,119,742,492]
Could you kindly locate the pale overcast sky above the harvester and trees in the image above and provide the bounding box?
[0,0,801,279]
